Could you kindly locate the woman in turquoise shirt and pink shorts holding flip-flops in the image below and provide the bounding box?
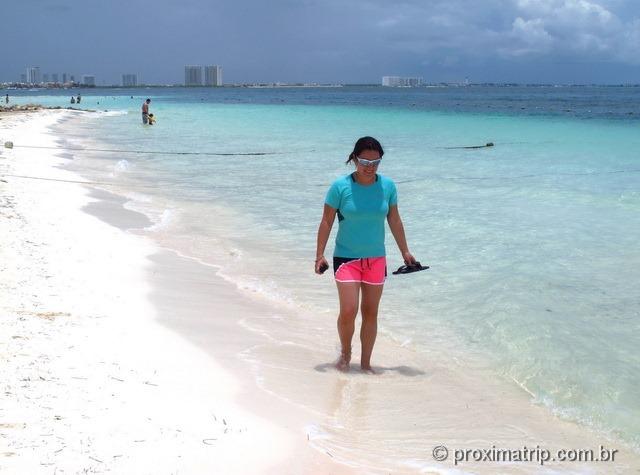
[315,137,415,373]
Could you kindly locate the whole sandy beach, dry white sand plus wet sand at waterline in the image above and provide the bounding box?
[0,111,640,474]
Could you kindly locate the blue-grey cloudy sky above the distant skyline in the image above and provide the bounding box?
[0,0,640,84]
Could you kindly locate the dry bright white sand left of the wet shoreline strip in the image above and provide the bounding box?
[0,111,342,474]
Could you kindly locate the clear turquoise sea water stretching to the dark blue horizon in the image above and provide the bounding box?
[9,87,640,458]
